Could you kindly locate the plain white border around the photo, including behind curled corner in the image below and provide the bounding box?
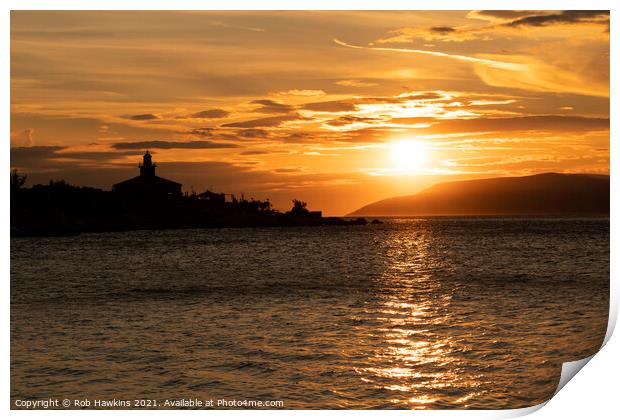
[0,0,620,419]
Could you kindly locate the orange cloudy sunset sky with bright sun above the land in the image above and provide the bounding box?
[10,10,610,215]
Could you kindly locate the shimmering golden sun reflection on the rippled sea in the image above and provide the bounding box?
[356,231,490,409]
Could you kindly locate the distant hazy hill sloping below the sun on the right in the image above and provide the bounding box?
[347,173,609,216]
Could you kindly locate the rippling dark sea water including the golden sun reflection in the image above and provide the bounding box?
[11,218,609,408]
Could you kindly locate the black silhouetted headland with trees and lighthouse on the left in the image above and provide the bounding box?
[11,151,367,236]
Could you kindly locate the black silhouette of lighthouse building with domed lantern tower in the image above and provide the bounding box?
[112,150,181,197]
